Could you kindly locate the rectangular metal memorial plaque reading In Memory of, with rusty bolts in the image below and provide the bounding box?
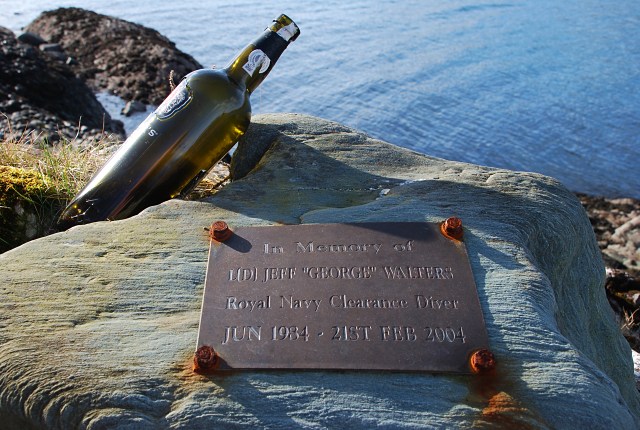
[198,223,489,373]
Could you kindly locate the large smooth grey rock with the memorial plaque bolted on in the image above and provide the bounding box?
[0,114,640,429]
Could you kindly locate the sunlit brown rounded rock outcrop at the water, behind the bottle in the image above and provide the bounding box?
[26,8,202,104]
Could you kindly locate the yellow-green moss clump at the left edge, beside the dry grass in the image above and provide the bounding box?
[0,166,64,252]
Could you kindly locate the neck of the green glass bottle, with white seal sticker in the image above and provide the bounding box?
[226,15,300,93]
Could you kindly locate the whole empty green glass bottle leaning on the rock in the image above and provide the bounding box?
[58,15,300,229]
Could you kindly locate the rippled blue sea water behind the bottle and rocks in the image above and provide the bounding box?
[0,0,640,198]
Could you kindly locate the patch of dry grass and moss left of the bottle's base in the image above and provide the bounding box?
[0,126,114,252]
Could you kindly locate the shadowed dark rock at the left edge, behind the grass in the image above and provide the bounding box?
[0,28,124,141]
